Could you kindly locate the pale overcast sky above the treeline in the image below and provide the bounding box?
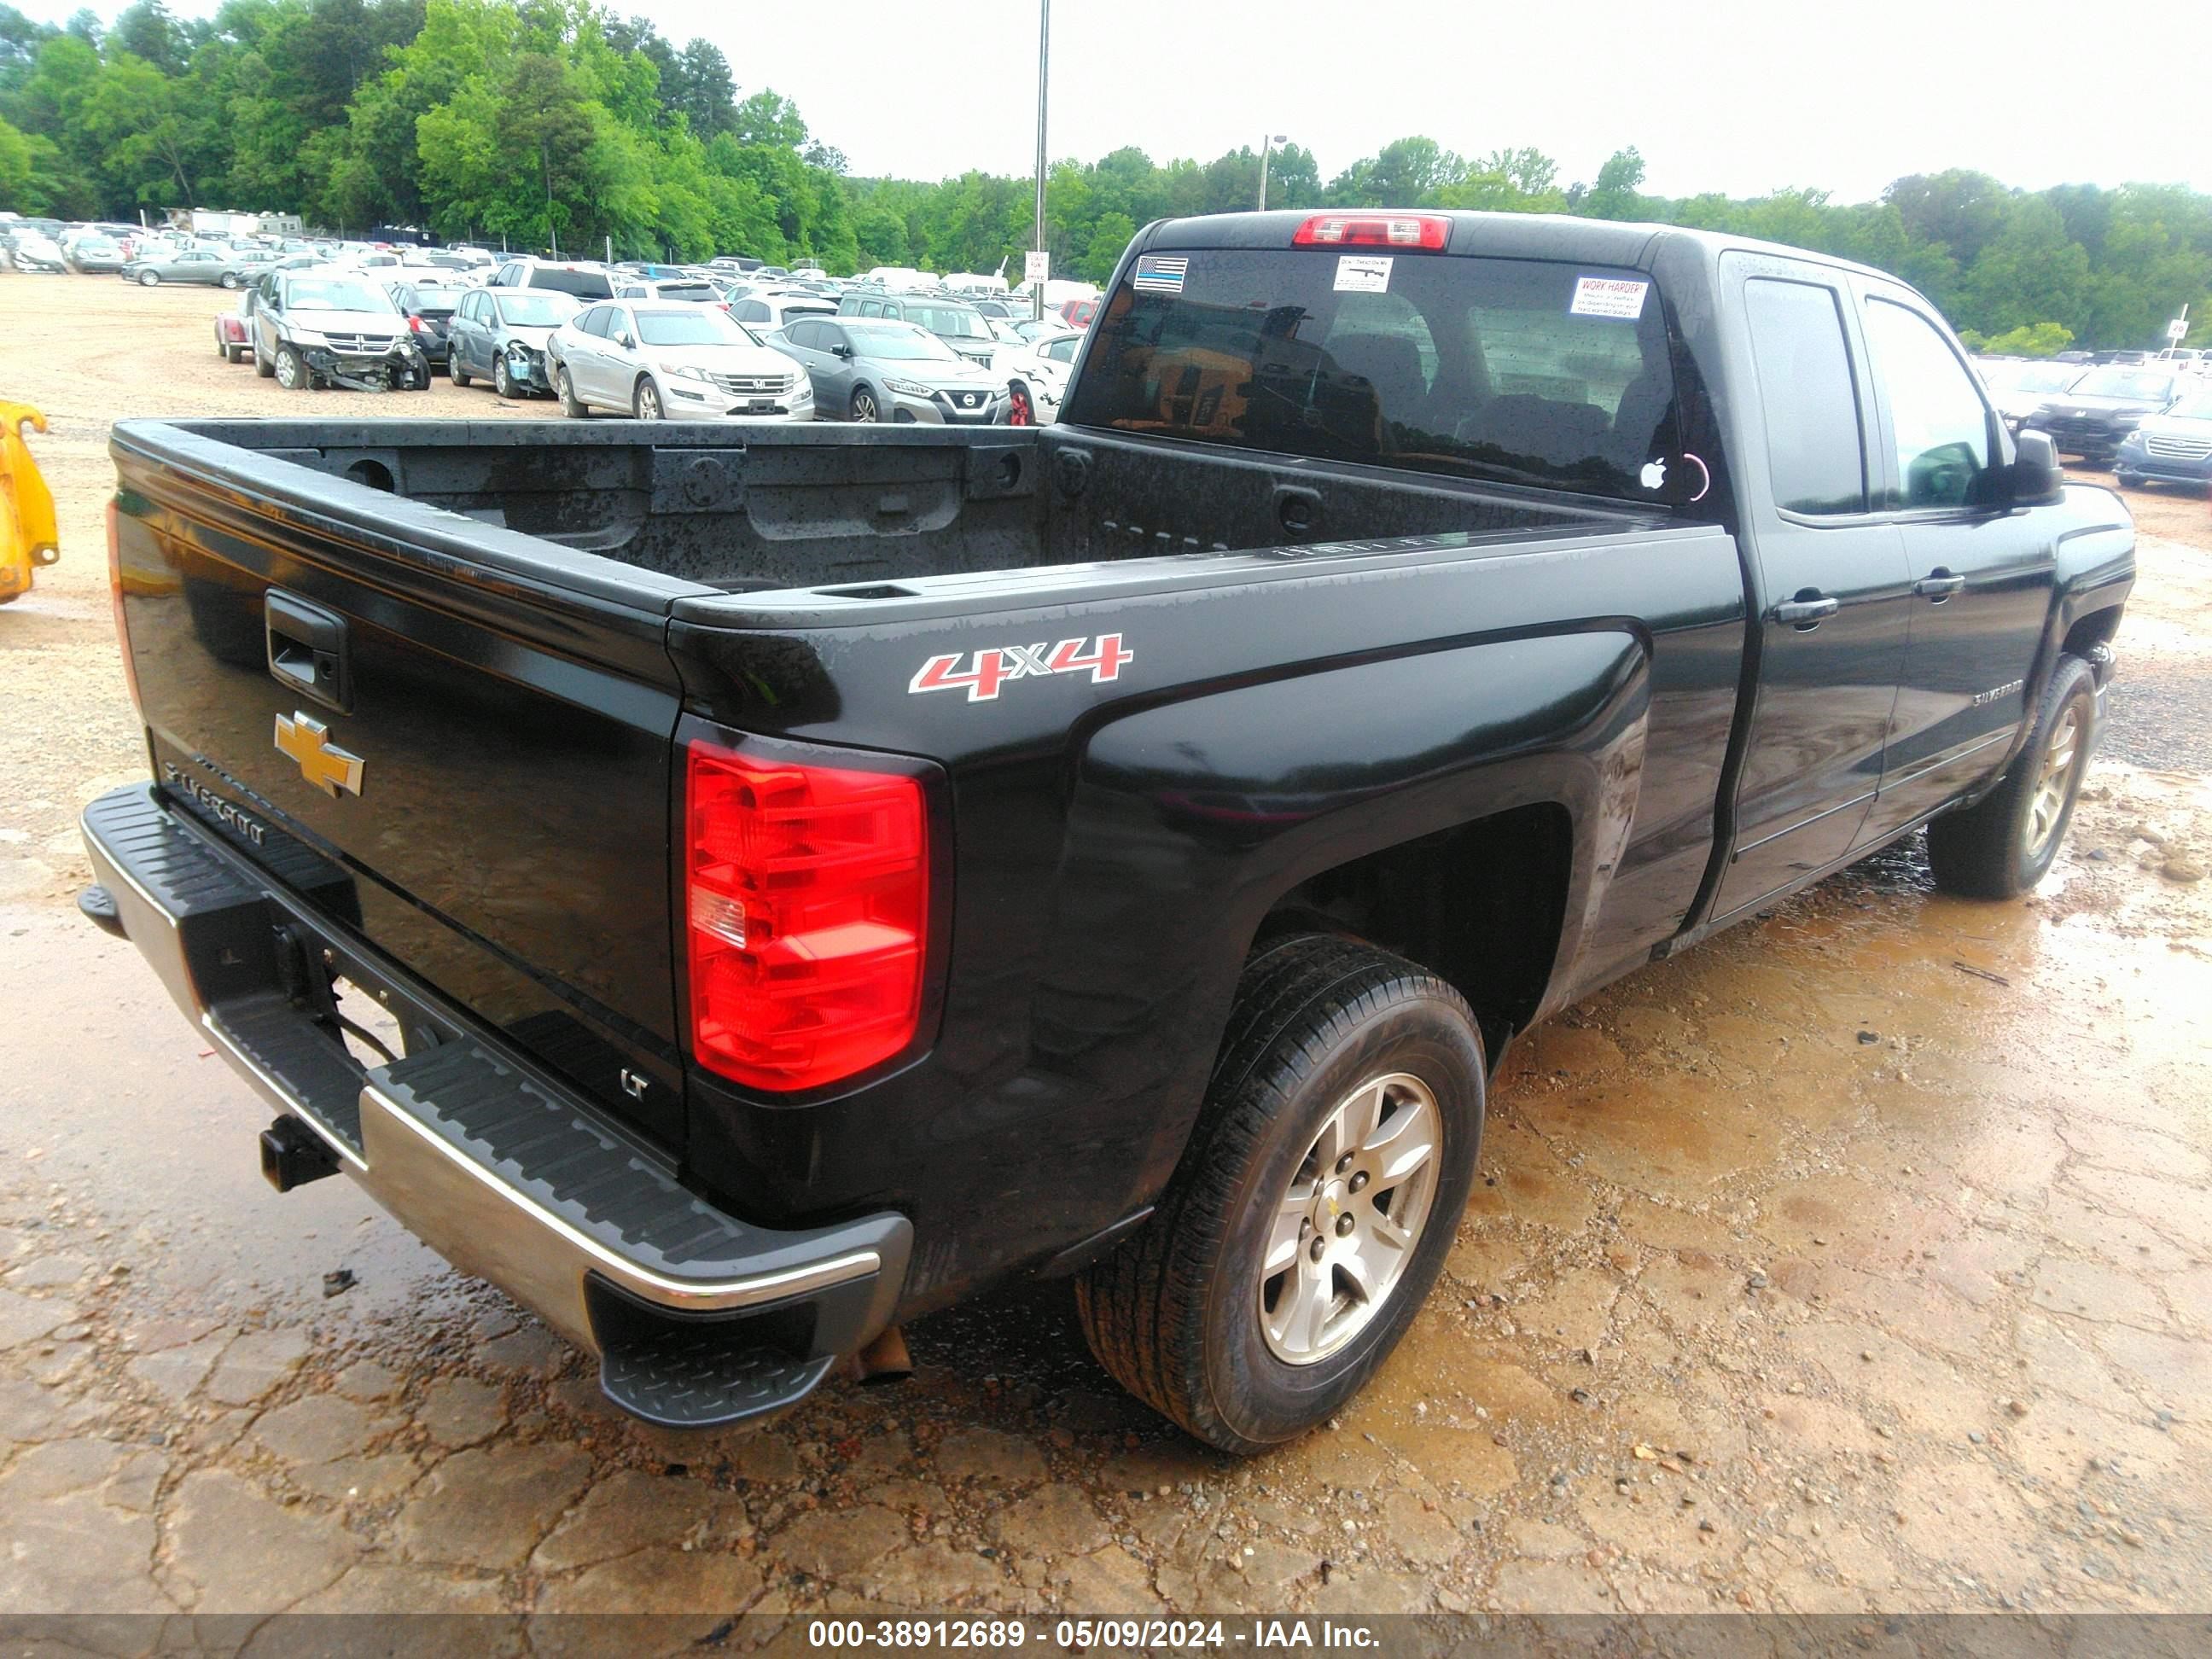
[30,0,2212,201]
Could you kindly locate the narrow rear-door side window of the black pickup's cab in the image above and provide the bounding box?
[1743,276,1867,518]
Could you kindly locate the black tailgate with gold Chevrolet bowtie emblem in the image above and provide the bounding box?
[113,425,690,1150]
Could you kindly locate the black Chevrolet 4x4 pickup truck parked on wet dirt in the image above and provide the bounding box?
[82,212,2134,1451]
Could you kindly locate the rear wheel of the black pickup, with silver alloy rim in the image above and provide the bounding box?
[1075,934,1487,1456]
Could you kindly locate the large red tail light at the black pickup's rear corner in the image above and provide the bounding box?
[684,743,929,1092]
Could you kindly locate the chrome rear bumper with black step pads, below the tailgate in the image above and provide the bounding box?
[84,783,911,1424]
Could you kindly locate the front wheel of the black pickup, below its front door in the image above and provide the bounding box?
[1929,657,2097,898]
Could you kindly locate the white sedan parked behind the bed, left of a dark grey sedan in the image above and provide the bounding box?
[546,301,814,420]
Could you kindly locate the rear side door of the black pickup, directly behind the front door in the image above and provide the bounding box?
[1712,254,1909,916]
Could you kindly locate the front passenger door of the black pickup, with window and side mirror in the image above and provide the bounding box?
[1860,283,2058,843]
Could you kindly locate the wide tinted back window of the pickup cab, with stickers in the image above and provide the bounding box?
[1062,247,1697,502]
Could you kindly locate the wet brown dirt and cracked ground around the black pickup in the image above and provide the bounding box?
[0,276,2212,1641]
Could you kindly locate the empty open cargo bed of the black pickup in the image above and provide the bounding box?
[117,420,1659,608]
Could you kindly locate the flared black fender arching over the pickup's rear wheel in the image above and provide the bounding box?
[1033,624,1650,1179]
